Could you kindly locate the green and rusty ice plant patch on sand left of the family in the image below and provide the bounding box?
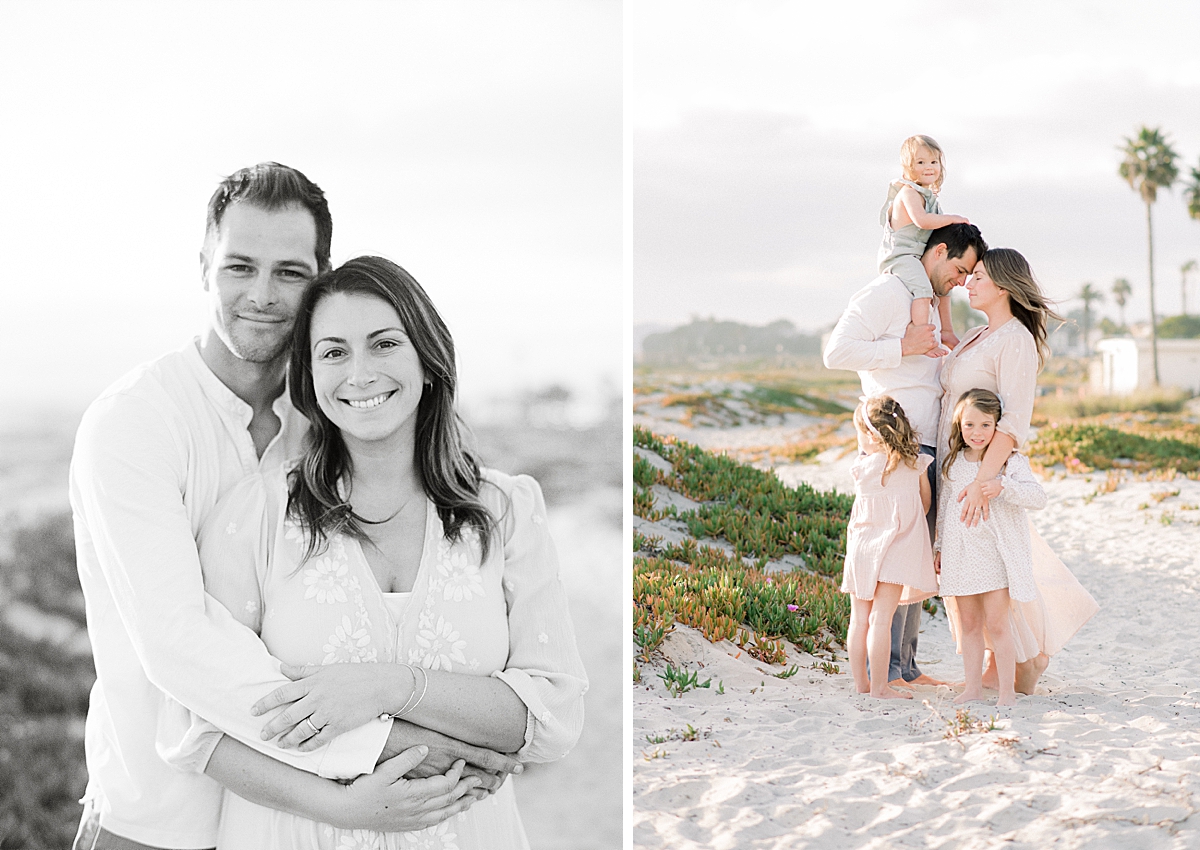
[634,427,853,664]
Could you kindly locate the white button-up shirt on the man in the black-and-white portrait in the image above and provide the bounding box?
[70,341,390,848]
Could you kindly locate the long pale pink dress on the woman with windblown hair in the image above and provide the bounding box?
[937,318,1100,662]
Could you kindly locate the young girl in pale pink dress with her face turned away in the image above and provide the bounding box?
[841,396,937,700]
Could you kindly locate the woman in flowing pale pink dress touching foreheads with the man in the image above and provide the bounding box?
[937,249,1099,694]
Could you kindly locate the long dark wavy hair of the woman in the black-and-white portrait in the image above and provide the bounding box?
[288,257,497,559]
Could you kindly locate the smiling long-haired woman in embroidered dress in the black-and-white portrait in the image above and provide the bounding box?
[182,257,587,850]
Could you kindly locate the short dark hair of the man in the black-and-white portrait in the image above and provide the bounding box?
[205,162,334,273]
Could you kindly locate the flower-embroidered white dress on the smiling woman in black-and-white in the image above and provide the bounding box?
[189,471,587,850]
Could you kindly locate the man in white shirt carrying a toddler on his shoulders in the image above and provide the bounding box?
[823,225,988,684]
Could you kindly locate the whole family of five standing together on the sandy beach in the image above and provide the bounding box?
[823,136,1098,706]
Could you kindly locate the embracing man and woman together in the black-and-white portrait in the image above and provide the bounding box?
[71,163,587,850]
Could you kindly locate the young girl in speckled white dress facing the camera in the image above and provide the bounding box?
[935,388,1046,706]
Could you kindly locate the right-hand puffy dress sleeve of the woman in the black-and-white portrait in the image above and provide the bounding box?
[492,475,588,761]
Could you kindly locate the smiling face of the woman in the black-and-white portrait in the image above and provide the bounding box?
[310,293,425,448]
